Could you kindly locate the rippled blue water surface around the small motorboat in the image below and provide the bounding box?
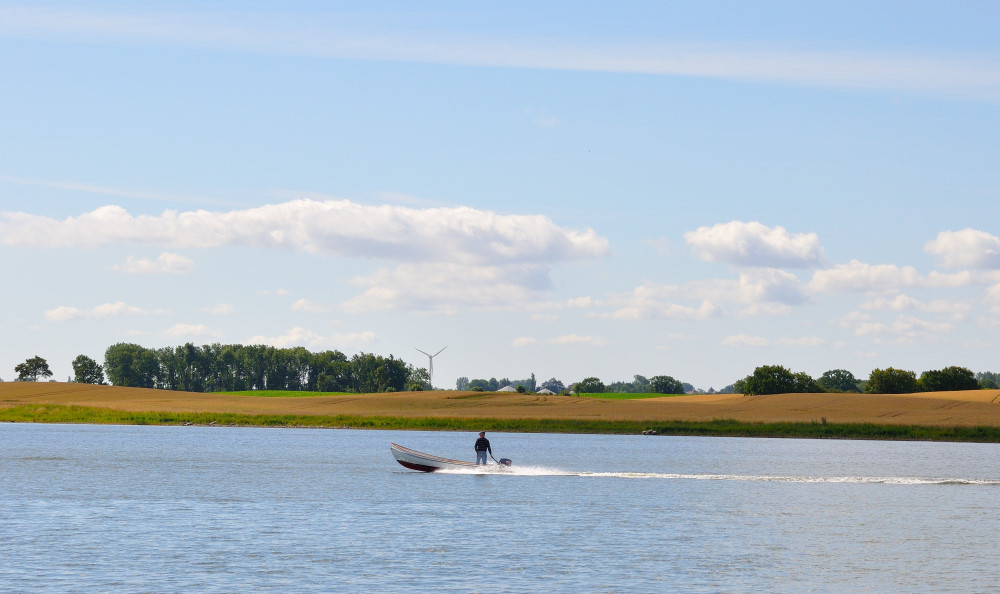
[0,424,1000,592]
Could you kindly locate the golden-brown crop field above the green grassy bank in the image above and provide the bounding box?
[0,382,1000,427]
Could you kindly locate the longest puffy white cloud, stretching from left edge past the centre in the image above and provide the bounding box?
[0,199,608,265]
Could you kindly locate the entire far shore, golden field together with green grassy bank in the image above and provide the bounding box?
[0,382,1000,442]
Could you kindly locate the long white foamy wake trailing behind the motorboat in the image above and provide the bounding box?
[435,465,1000,486]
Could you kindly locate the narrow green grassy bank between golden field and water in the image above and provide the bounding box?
[0,404,1000,443]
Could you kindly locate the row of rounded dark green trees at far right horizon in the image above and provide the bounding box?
[736,365,1000,396]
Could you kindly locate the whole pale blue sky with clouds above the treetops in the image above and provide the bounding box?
[0,0,1000,390]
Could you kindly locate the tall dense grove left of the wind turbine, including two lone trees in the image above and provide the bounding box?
[6,343,431,394]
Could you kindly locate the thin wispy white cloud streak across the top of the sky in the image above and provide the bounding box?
[0,6,1000,99]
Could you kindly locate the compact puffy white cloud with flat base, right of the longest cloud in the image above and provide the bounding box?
[684,221,825,268]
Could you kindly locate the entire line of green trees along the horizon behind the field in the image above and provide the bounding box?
[9,350,1000,395]
